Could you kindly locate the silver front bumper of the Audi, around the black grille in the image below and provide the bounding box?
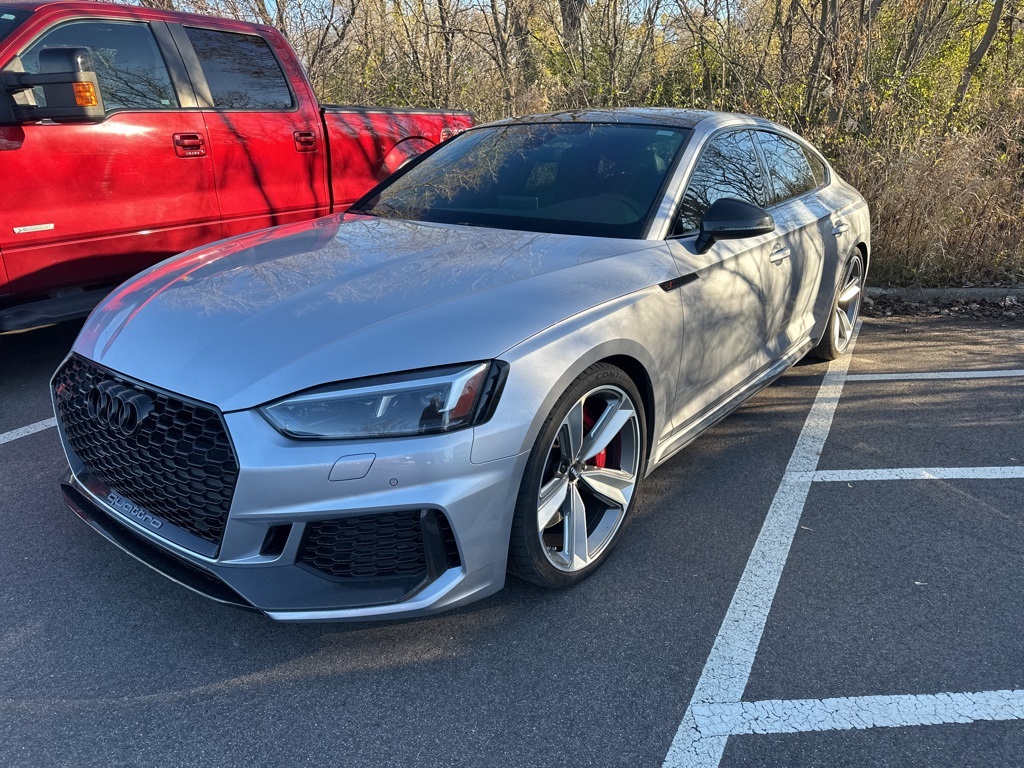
[61,412,525,622]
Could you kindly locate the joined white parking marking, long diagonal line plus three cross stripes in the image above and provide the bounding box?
[664,323,1024,768]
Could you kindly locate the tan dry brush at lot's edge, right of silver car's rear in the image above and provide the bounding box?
[838,115,1024,287]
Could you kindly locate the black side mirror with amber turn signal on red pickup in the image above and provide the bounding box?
[0,48,105,125]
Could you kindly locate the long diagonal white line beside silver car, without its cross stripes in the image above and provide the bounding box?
[665,322,860,768]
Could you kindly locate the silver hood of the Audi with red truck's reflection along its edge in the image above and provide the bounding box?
[75,215,673,411]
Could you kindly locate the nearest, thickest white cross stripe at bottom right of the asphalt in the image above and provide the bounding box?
[694,690,1024,736]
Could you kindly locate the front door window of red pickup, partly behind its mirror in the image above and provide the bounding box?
[20,19,178,112]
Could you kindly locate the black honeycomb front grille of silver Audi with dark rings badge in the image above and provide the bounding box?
[53,355,239,548]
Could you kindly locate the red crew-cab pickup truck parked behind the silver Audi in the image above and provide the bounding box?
[0,0,472,332]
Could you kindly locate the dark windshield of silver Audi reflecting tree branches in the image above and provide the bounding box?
[351,123,689,238]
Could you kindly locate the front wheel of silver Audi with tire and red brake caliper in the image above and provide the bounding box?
[509,362,647,589]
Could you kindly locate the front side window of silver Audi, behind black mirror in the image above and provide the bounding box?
[676,131,765,231]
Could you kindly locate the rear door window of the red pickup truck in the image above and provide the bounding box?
[185,27,292,112]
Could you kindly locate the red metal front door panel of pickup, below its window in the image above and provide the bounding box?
[0,112,220,295]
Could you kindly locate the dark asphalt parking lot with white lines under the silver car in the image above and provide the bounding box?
[0,317,1024,767]
